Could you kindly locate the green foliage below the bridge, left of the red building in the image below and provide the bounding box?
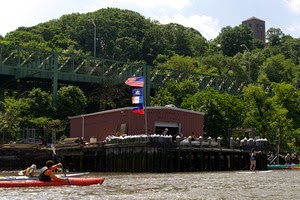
[0,86,86,142]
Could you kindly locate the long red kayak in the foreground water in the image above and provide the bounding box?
[0,177,104,187]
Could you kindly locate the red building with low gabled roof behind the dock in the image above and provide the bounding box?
[69,106,204,141]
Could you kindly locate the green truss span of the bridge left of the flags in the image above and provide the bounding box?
[0,44,143,84]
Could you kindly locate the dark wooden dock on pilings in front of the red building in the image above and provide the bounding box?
[52,136,267,173]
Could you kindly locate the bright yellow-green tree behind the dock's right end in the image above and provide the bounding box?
[243,82,293,151]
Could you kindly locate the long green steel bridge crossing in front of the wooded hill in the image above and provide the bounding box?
[0,44,260,104]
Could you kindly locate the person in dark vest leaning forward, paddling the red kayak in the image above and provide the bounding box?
[39,160,66,181]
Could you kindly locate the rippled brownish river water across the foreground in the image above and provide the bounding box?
[0,170,300,200]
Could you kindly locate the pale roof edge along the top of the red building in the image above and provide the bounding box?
[69,105,205,119]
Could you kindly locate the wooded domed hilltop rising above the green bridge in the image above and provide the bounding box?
[2,8,207,64]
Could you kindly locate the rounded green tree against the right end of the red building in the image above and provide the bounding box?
[181,88,244,143]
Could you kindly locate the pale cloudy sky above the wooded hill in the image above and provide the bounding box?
[0,0,300,40]
